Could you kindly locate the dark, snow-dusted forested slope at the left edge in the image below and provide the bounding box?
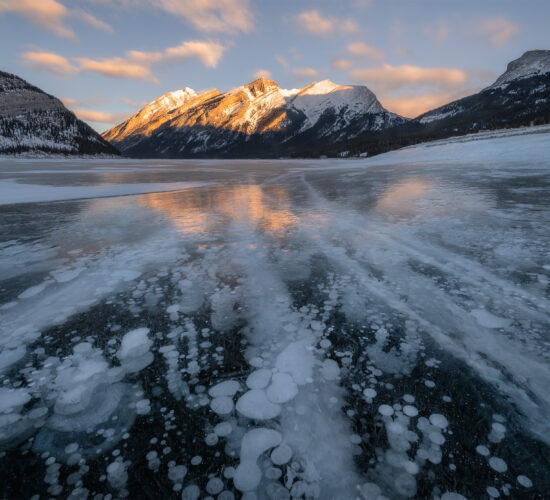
[0,71,120,155]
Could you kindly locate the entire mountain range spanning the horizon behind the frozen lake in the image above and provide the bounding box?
[0,50,550,158]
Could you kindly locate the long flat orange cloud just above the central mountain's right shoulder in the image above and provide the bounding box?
[351,64,468,91]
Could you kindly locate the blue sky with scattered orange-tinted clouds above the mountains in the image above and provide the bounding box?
[0,0,550,131]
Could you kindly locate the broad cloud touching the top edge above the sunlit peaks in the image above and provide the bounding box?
[150,0,254,35]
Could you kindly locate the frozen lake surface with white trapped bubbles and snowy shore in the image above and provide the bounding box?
[0,129,550,500]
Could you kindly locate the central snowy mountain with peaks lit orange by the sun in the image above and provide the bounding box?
[103,78,406,158]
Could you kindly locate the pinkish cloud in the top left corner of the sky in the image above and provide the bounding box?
[0,0,76,40]
